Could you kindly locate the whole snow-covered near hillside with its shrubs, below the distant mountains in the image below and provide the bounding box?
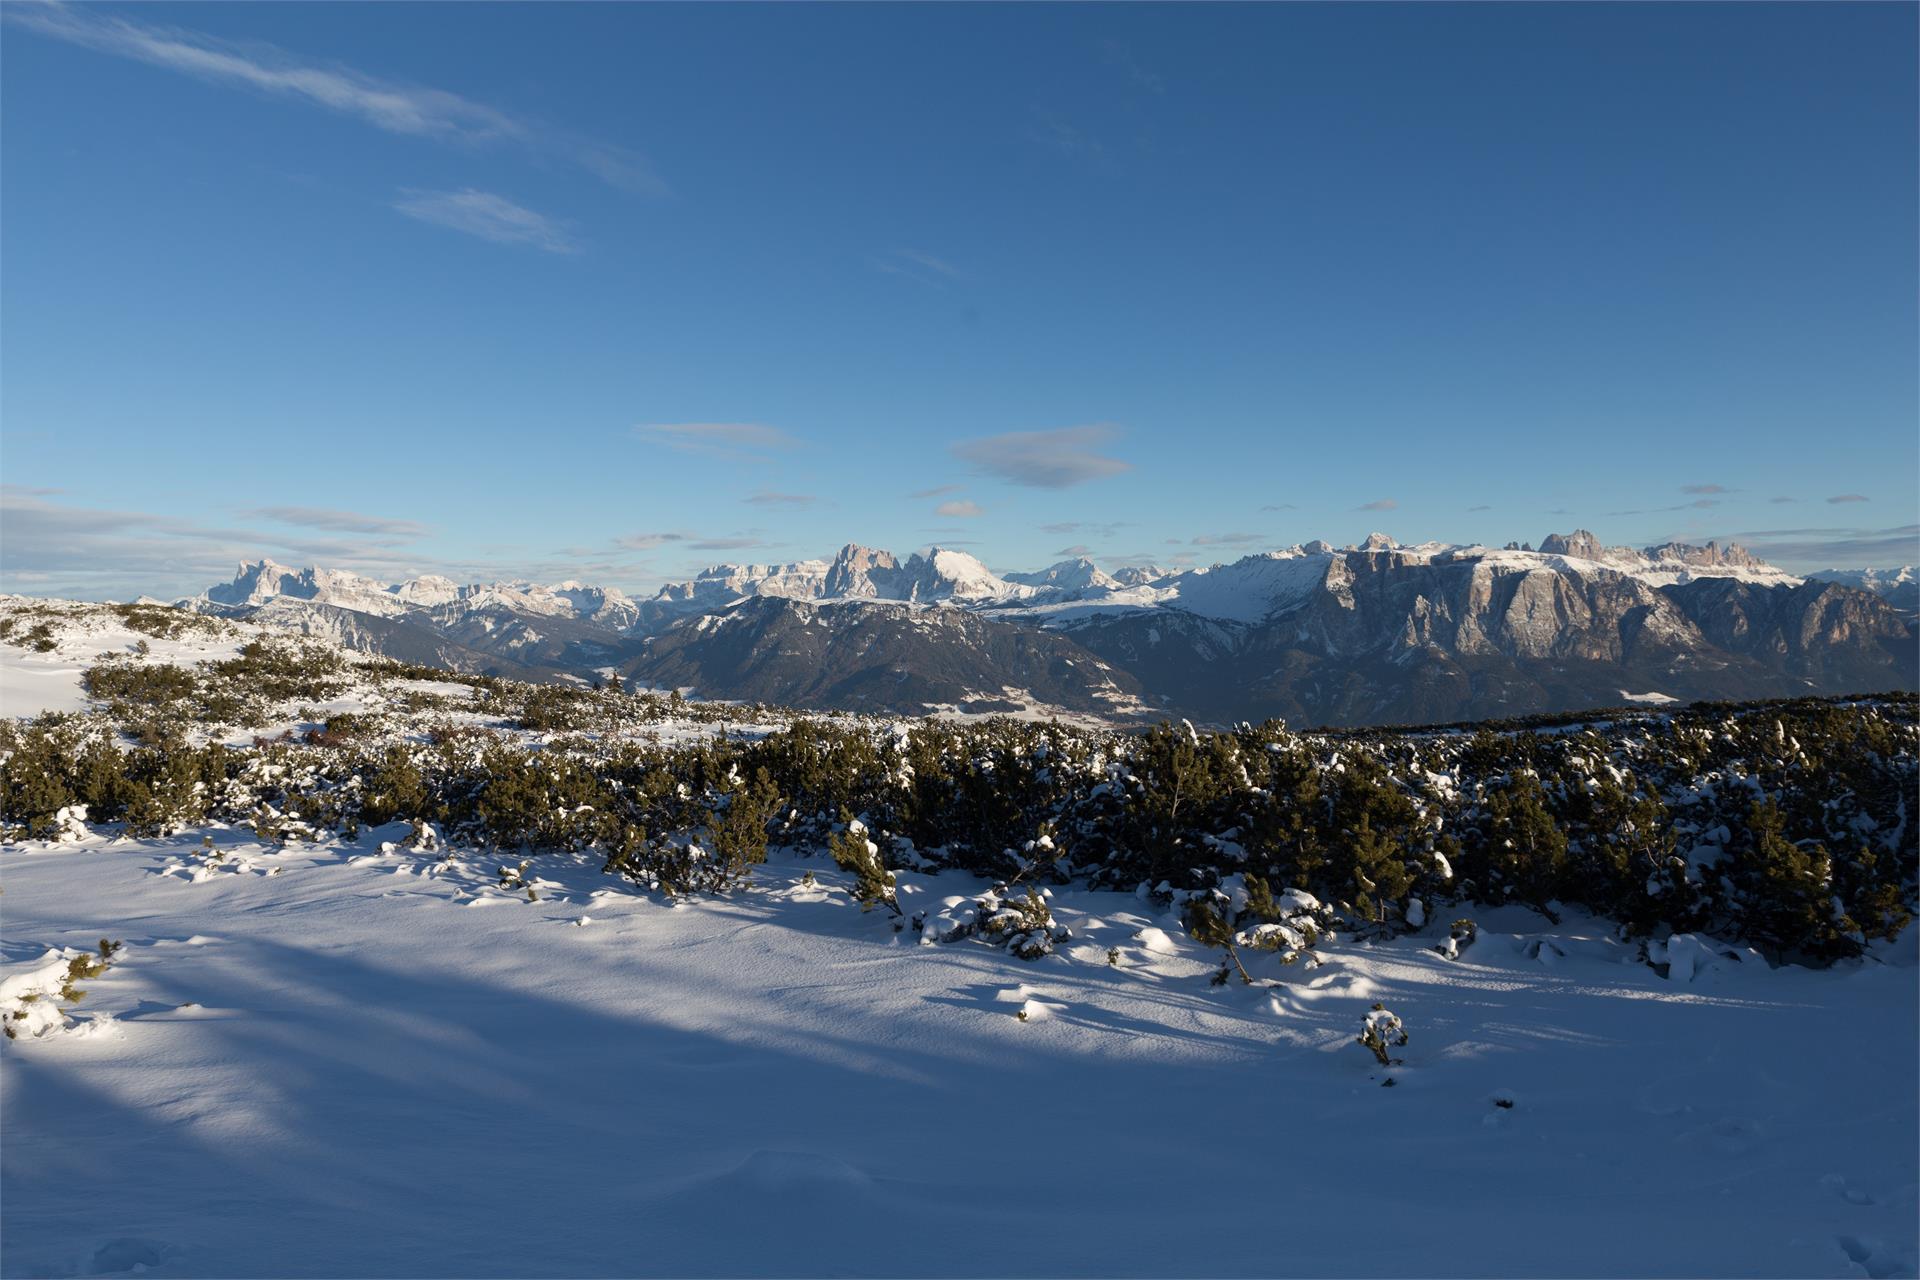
[0,602,1920,1276]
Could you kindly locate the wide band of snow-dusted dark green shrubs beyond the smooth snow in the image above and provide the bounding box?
[0,629,1920,971]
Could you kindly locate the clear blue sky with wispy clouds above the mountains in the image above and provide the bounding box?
[0,4,1920,595]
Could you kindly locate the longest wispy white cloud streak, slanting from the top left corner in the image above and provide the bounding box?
[4,4,666,196]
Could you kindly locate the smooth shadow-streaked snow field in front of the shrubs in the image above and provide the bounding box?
[0,829,1920,1276]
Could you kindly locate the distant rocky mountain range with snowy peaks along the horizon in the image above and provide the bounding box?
[182,530,1920,723]
